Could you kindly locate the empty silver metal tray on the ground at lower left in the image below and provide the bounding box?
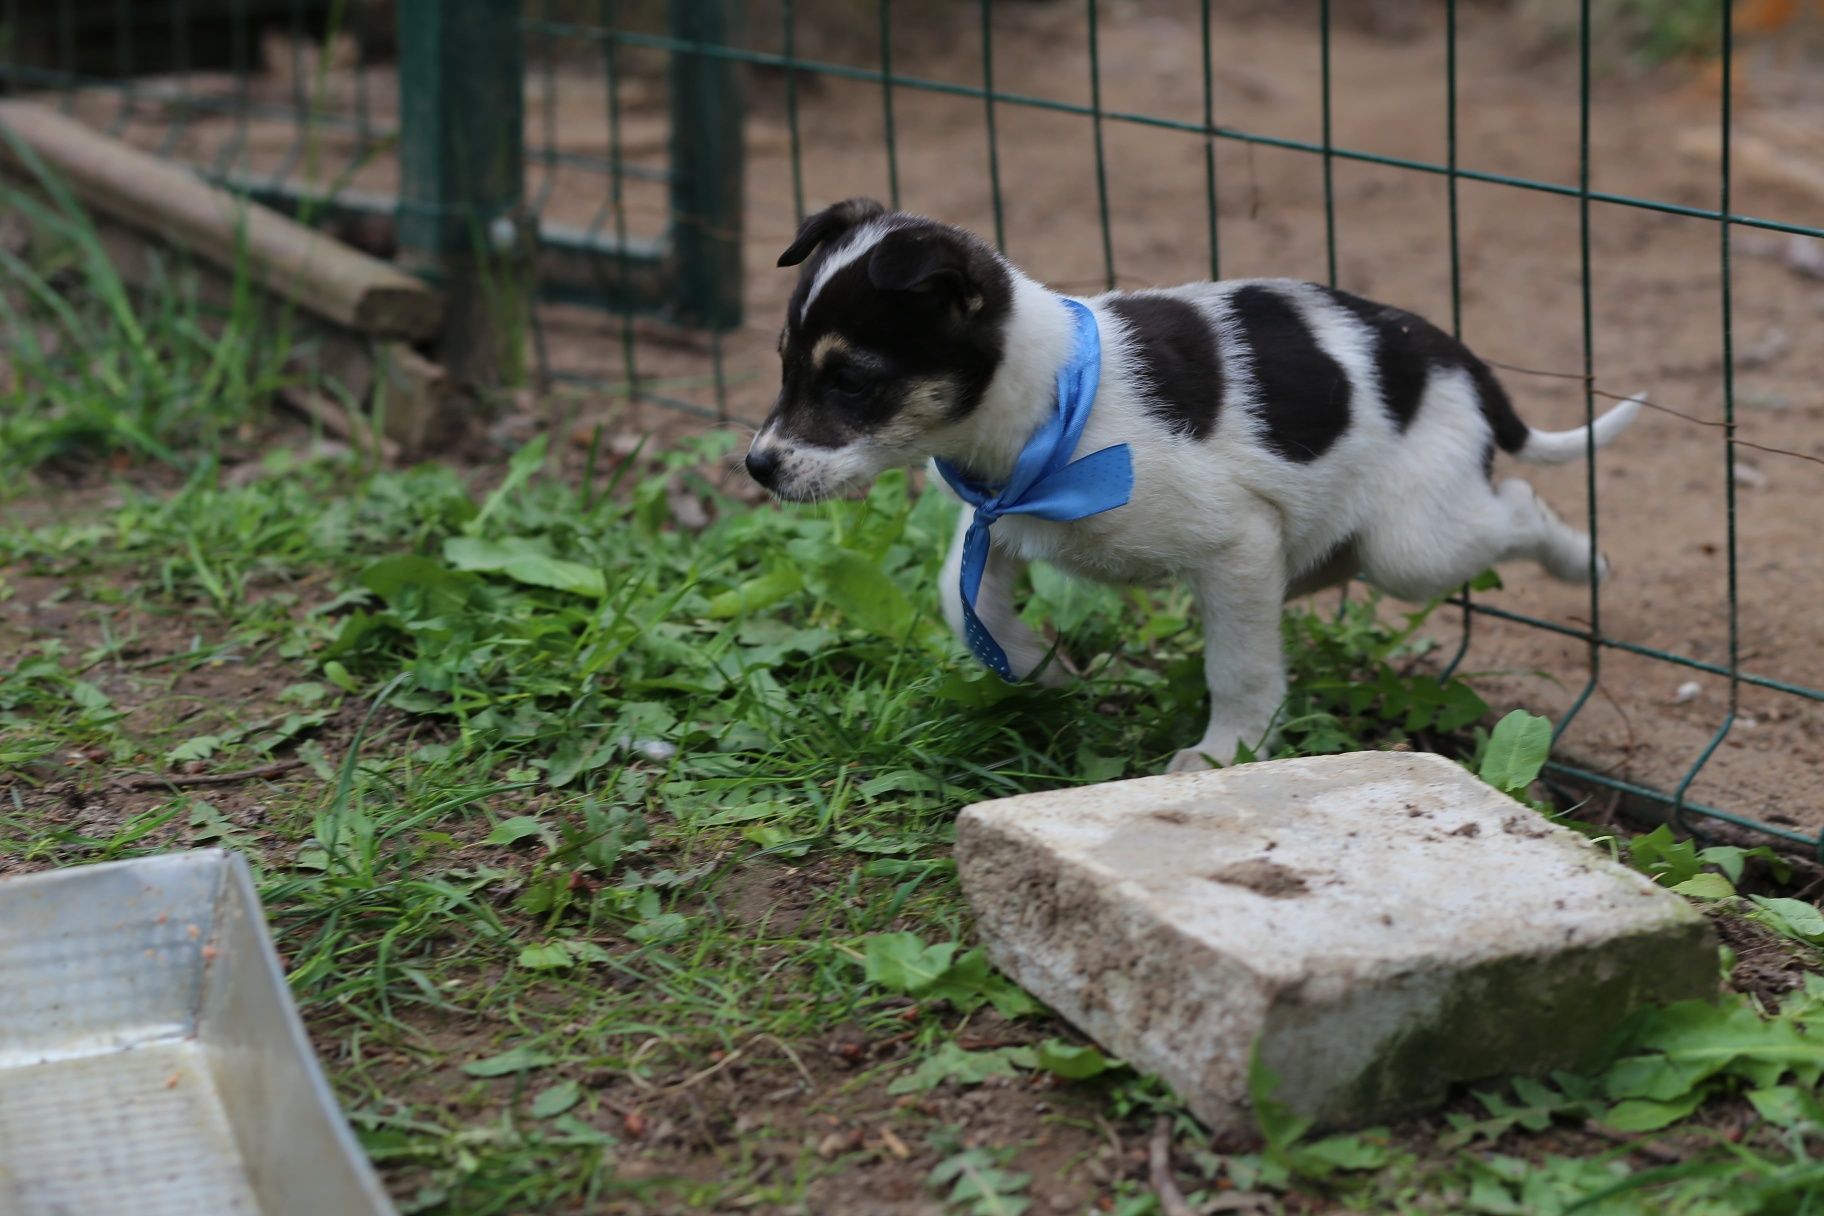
[0,850,394,1216]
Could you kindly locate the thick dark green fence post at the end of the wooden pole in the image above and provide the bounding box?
[398,0,531,385]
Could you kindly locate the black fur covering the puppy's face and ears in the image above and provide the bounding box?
[773,215,1012,447]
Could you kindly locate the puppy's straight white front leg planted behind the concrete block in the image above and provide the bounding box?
[1167,516,1286,773]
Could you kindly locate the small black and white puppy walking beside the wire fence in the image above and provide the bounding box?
[748,199,1640,771]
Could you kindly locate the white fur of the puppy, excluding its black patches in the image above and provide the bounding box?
[757,260,1640,771]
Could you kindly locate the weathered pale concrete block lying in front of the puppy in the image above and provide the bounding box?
[956,753,1716,1130]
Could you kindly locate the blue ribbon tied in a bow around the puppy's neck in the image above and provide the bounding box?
[932,299,1135,680]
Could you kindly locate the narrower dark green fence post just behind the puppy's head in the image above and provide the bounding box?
[669,0,744,330]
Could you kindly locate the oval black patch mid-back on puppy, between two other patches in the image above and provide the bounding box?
[1229,286,1350,463]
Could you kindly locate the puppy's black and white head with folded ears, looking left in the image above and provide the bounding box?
[748,199,1012,501]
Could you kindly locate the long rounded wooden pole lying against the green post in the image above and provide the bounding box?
[0,100,443,341]
